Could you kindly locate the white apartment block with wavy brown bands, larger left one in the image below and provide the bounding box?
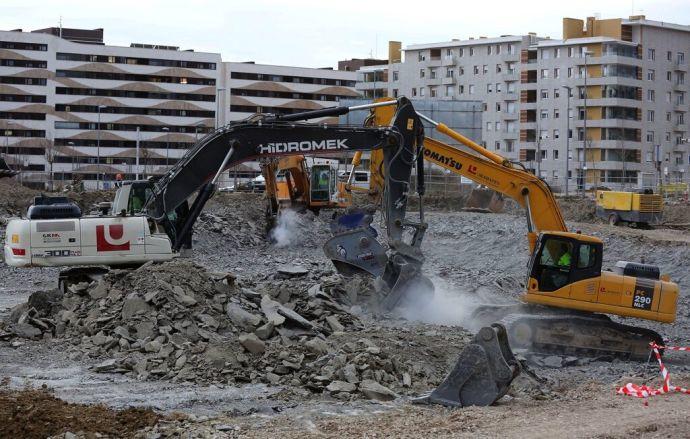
[0,28,222,188]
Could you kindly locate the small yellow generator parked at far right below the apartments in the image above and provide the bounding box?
[596,189,664,225]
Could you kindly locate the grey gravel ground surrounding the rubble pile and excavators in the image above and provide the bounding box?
[0,196,690,438]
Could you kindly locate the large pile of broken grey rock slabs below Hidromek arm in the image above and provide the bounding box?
[5,259,461,400]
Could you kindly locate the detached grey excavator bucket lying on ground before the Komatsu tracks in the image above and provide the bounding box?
[413,323,520,407]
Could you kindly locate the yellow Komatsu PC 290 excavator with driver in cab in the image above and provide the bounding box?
[325,99,678,359]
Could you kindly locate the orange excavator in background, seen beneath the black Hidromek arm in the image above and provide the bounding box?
[261,155,352,230]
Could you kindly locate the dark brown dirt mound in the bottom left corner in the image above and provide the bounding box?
[0,388,162,439]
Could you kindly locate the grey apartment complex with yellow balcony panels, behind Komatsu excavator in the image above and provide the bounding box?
[376,16,690,192]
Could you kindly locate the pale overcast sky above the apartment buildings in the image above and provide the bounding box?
[0,0,690,67]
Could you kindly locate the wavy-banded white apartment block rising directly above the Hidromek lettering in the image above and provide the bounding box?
[221,62,359,122]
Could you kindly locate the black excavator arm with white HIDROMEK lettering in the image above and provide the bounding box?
[139,98,427,303]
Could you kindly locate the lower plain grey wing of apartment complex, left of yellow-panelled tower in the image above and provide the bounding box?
[388,34,537,163]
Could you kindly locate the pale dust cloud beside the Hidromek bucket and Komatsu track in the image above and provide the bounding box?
[400,278,482,328]
